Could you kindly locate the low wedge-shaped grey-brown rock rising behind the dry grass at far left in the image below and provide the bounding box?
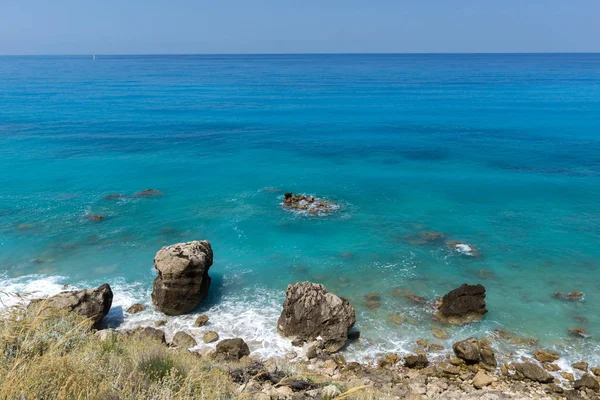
[29,283,113,327]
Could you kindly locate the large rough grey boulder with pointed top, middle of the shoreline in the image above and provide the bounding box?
[277,282,356,353]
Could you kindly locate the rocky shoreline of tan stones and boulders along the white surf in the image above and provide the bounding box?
[12,241,600,400]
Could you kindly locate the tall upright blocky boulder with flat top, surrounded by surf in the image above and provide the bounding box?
[152,240,213,315]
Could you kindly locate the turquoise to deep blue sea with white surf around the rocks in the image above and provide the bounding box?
[0,54,600,365]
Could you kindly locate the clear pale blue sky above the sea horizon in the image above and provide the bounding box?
[0,0,600,54]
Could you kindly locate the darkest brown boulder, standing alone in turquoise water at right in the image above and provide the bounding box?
[434,284,487,324]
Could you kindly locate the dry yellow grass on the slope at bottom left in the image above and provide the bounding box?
[0,307,235,400]
